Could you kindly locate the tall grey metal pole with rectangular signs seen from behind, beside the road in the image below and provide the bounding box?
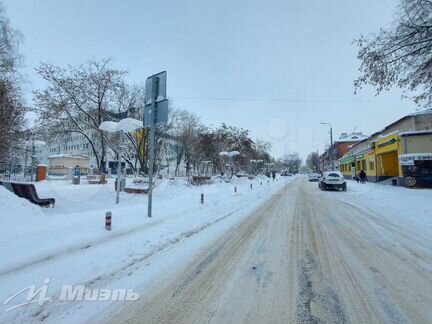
[144,71,168,217]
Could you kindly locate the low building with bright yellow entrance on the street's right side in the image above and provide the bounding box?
[339,110,432,185]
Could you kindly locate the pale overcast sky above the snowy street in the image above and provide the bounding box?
[3,0,416,158]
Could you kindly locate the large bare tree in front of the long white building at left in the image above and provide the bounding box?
[34,59,126,170]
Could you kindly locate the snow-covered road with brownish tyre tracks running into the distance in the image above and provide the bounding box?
[95,177,432,324]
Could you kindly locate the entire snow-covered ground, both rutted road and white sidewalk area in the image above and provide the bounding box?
[0,176,432,324]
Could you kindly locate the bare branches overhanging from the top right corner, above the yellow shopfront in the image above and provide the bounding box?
[354,0,432,107]
